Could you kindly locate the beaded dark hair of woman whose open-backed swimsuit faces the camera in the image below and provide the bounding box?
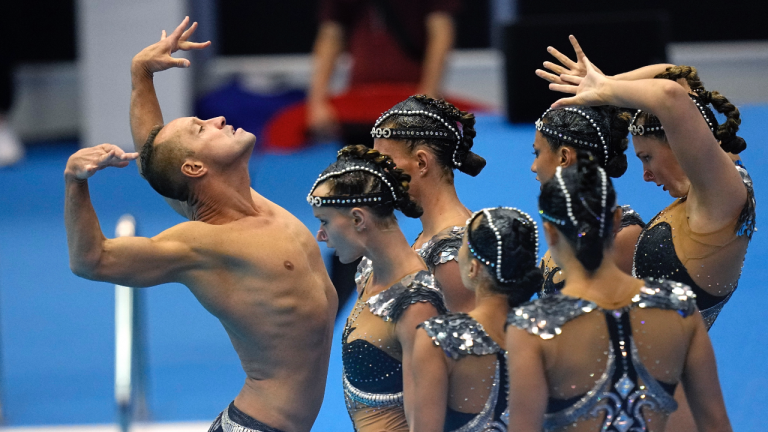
[539,155,616,273]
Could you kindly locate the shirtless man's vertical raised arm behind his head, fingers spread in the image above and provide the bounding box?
[130,17,211,157]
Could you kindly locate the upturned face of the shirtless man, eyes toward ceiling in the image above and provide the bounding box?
[156,117,256,167]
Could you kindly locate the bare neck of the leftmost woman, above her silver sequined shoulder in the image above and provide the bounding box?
[365,225,427,295]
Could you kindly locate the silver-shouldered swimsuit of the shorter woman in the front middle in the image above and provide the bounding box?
[419,313,509,432]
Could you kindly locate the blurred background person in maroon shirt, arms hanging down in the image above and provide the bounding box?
[307,0,461,136]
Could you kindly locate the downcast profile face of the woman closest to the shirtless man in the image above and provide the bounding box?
[312,183,365,264]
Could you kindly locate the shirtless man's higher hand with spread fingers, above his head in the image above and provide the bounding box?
[132,17,211,76]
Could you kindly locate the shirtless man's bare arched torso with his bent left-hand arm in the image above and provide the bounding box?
[65,144,337,432]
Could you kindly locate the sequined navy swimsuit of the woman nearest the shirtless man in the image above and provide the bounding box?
[341,258,446,431]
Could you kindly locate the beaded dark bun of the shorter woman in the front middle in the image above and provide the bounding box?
[466,207,544,307]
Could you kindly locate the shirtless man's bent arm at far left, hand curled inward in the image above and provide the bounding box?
[64,144,198,287]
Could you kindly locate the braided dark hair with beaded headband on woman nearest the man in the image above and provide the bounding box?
[312,144,424,218]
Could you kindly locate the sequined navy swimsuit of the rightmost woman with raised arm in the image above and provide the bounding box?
[632,165,755,328]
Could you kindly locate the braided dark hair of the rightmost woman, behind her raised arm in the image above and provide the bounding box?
[637,65,747,154]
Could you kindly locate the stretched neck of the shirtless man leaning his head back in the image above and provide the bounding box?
[188,179,262,225]
